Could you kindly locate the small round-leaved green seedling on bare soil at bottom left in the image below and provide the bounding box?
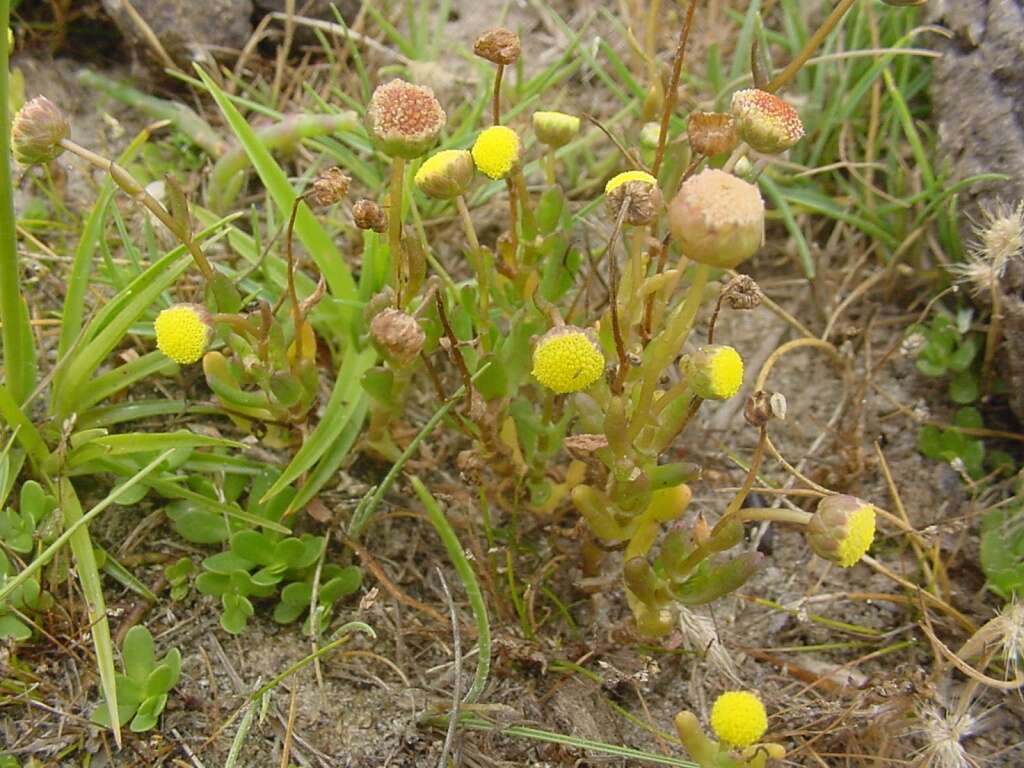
[92,627,181,733]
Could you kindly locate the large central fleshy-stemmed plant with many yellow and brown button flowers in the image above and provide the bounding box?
[339,19,874,636]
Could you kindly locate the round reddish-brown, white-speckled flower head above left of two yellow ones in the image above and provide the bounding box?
[368,80,447,160]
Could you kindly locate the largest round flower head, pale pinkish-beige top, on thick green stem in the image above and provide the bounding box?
[669,168,765,268]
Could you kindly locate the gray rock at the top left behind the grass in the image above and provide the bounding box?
[103,0,253,66]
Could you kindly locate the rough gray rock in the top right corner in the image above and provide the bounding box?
[930,0,1024,212]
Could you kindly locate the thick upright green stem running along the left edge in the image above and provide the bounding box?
[0,0,37,404]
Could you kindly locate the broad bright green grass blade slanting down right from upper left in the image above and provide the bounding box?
[196,67,358,336]
